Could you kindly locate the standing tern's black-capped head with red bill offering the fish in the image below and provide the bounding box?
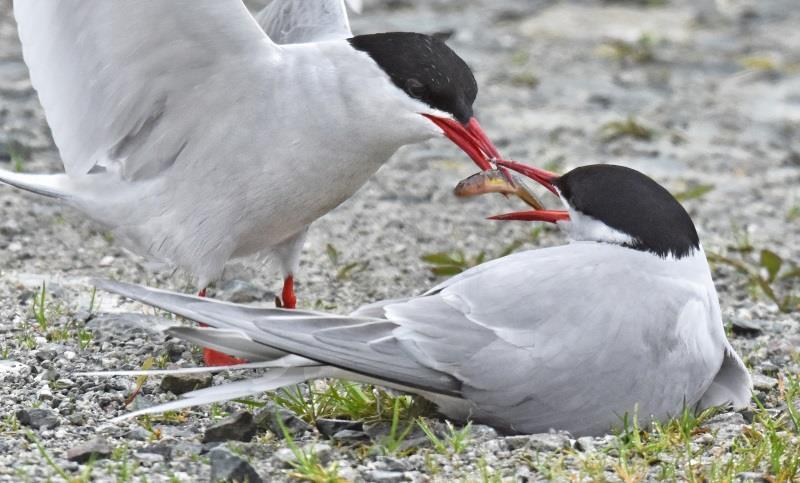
[349,32,500,170]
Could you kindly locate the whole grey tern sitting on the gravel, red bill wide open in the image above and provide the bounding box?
[87,162,751,435]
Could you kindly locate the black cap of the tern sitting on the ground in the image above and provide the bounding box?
[554,164,700,258]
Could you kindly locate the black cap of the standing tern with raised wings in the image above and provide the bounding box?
[350,32,478,124]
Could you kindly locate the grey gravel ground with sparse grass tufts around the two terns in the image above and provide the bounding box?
[0,0,800,482]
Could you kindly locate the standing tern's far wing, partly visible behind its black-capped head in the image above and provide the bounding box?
[256,0,361,44]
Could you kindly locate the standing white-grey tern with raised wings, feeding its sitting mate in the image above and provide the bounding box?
[0,0,510,364]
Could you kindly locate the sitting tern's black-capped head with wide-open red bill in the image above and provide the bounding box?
[492,161,700,258]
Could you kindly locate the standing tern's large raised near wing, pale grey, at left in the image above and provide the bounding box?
[14,0,279,179]
